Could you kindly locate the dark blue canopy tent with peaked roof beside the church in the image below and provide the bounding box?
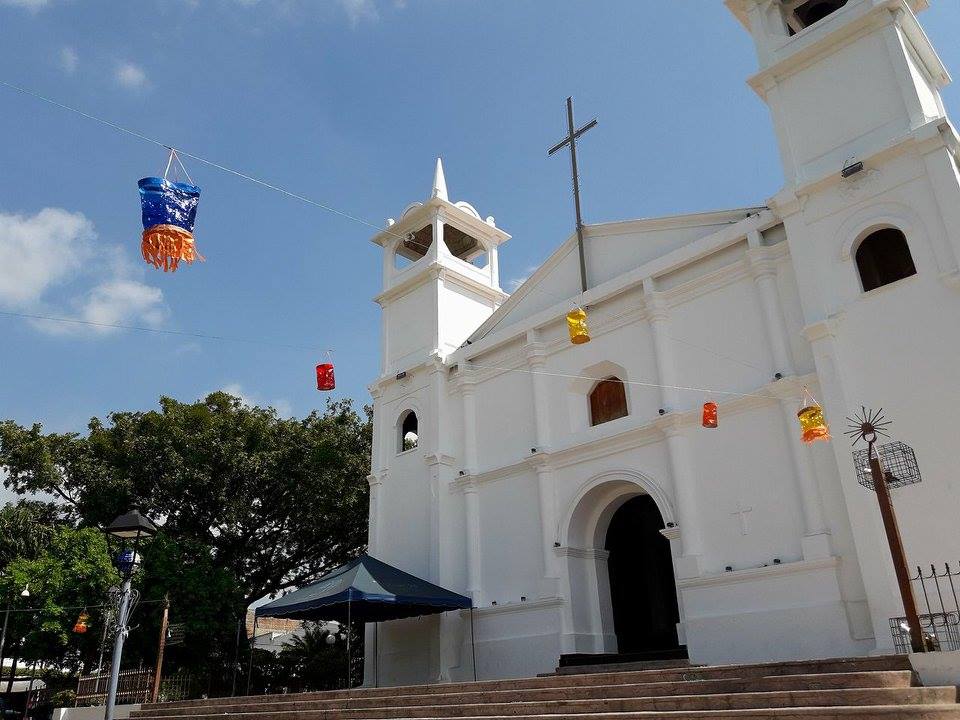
[248,554,477,691]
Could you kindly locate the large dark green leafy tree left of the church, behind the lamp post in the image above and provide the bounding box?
[0,392,371,664]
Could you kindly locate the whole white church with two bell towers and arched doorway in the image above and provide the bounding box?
[366,0,960,684]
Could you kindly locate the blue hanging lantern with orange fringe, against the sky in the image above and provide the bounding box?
[138,177,203,272]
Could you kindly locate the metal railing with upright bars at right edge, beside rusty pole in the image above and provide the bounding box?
[890,563,960,653]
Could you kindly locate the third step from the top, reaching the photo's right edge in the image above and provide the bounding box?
[129,687,957,720]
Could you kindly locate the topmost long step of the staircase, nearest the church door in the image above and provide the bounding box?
[144,655,910,709]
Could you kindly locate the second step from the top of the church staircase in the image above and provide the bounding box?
[127,670,913,719]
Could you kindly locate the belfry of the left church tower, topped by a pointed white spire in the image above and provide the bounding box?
[373,158,510,376]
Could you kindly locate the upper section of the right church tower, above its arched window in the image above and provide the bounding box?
[726,0,950,186]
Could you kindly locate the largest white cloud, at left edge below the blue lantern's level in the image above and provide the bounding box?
[0,208,168,335]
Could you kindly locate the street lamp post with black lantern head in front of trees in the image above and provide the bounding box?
[103,510,157,720]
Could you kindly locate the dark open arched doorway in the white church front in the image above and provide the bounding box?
[604,494,680,654]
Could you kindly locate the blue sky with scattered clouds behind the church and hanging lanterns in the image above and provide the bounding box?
[0,0,960,431]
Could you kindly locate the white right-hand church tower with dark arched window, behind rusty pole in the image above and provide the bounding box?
[726,0,960,651]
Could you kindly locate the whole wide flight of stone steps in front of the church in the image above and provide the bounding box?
[131,655,960,720]
